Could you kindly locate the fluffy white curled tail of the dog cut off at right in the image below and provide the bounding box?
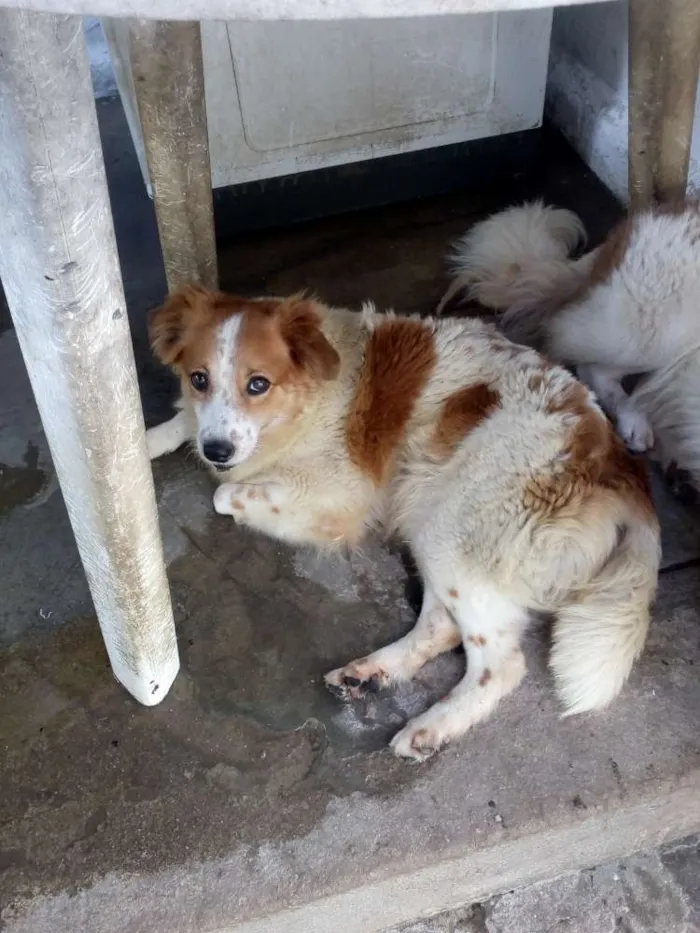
[437,201,595,334]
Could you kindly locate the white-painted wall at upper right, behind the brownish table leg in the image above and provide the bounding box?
[546,0,700,201]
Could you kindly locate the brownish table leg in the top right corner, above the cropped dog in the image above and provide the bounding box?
[629,0,700,208]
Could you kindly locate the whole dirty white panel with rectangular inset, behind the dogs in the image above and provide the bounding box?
[202,9,551,187]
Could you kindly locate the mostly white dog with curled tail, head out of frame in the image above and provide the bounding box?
[437,203,700,490]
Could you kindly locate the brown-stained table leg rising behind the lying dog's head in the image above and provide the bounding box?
[129,20,218,290]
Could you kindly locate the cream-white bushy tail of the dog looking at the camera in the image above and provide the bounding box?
[550,502,660,716]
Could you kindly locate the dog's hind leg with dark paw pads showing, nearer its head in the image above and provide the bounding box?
[324,587,461,699]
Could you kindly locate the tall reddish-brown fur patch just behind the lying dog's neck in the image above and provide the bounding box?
[345,317,437,485]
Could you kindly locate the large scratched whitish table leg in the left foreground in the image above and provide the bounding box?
[0,9,179,705]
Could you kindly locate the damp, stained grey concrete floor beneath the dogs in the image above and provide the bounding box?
[0,100,700,933]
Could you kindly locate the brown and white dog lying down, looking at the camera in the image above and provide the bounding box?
[148,287,659,760]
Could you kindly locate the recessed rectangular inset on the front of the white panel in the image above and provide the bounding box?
[228,16,497,152]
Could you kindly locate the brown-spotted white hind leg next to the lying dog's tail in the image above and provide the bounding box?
[391,584,528,761]
